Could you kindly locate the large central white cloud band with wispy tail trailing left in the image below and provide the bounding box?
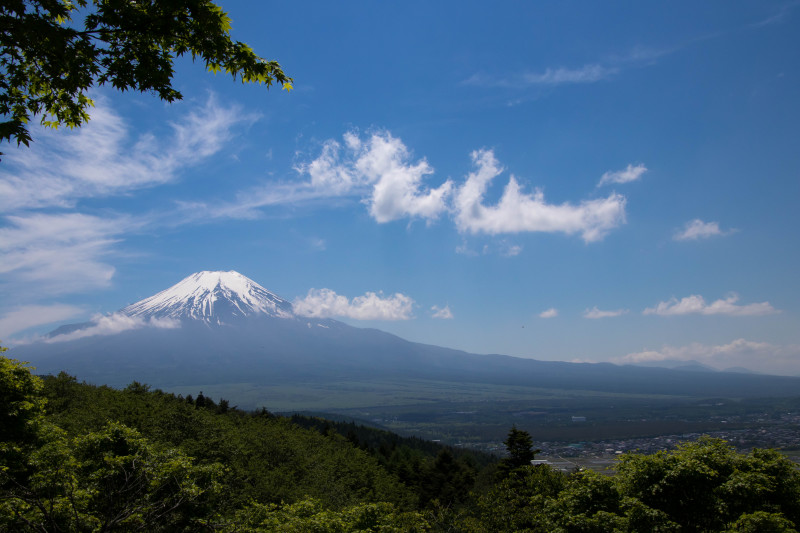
[200,131,626,245]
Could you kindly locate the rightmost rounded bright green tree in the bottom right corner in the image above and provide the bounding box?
[615,438,800,531]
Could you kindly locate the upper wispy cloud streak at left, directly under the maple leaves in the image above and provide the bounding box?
[0,98,250,213]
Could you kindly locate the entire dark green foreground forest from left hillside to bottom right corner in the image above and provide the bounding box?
[0,350,800,533]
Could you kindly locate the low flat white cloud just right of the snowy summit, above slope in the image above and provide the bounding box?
[293,289,414,320]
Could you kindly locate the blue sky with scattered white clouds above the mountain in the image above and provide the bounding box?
[0,1,800,375]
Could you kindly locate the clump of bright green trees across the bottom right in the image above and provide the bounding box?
[464,438,800,533]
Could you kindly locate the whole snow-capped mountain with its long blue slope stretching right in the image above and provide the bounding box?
[13,271,800,397]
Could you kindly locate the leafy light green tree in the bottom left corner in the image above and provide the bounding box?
[0,422,221,531]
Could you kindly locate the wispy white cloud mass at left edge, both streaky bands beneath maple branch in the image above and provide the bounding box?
[0,96,253,301]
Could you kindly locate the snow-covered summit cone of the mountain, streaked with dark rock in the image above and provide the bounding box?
[121,270,294,324]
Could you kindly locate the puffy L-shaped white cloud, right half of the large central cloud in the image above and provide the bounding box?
[454,150,625,242]
